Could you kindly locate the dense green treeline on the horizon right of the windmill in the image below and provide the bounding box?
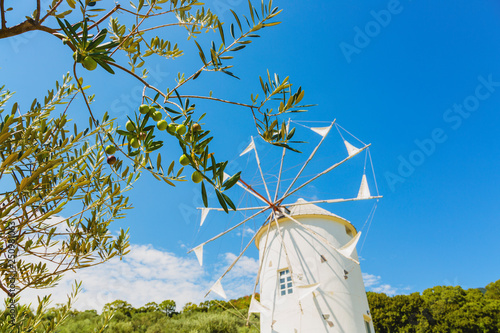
[368,280,500,333]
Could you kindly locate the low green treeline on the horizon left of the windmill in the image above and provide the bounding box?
[40,296,259,333]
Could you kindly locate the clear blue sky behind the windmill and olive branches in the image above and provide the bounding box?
[0,0,500,305]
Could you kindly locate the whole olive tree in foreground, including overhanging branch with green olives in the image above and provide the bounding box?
[0,0,307,331]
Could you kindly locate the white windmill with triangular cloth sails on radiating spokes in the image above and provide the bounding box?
[189,121,381,333]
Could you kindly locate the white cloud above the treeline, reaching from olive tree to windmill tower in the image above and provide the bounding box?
[16,245,258,311]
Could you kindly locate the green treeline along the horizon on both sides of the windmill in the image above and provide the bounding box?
[16,280,500,333]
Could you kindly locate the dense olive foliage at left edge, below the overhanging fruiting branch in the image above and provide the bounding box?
[0,75,137,332]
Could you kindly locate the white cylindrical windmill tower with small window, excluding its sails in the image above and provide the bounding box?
[255,199,374,333]
